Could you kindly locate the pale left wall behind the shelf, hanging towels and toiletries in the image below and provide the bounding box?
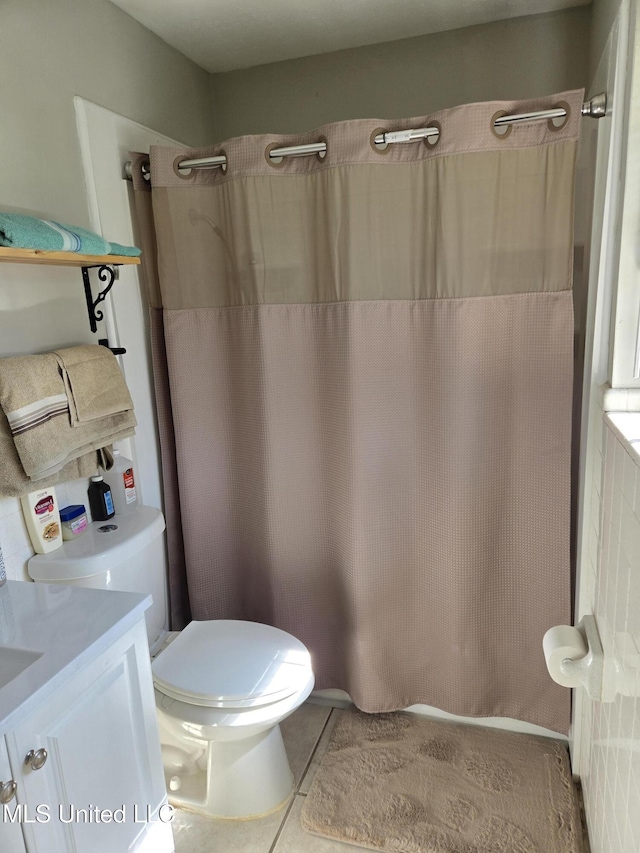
[0,0,213,579]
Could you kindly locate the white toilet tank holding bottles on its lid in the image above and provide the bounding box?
[28,506,168,650]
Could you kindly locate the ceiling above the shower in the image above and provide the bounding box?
[112,0,590,73]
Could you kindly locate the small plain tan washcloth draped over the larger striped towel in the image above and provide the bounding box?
[53,345,133,427]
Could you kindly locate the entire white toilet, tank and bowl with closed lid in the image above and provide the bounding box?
[28,506,314,819]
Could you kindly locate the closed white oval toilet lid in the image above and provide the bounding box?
[152,620,312,708]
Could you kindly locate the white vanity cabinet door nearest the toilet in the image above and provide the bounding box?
[7,622,173,853]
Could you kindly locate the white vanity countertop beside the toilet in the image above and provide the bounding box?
[0,581,151,734]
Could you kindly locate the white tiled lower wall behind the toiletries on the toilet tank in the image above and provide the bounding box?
[0,480,91,581]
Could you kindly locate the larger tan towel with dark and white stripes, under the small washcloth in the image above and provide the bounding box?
[0,347,136,481]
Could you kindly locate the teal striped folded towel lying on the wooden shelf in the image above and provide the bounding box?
[0,212,140,256]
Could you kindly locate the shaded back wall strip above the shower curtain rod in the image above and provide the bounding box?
[211,6,591,141]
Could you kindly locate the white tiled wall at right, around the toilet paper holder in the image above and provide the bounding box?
[579,415,640,853]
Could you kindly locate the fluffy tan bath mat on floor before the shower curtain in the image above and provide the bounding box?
[302,711,585,853]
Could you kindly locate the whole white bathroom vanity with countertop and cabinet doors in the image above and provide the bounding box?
[0,581,174,853]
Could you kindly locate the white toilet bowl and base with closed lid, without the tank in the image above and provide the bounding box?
[152,620,314,818]
